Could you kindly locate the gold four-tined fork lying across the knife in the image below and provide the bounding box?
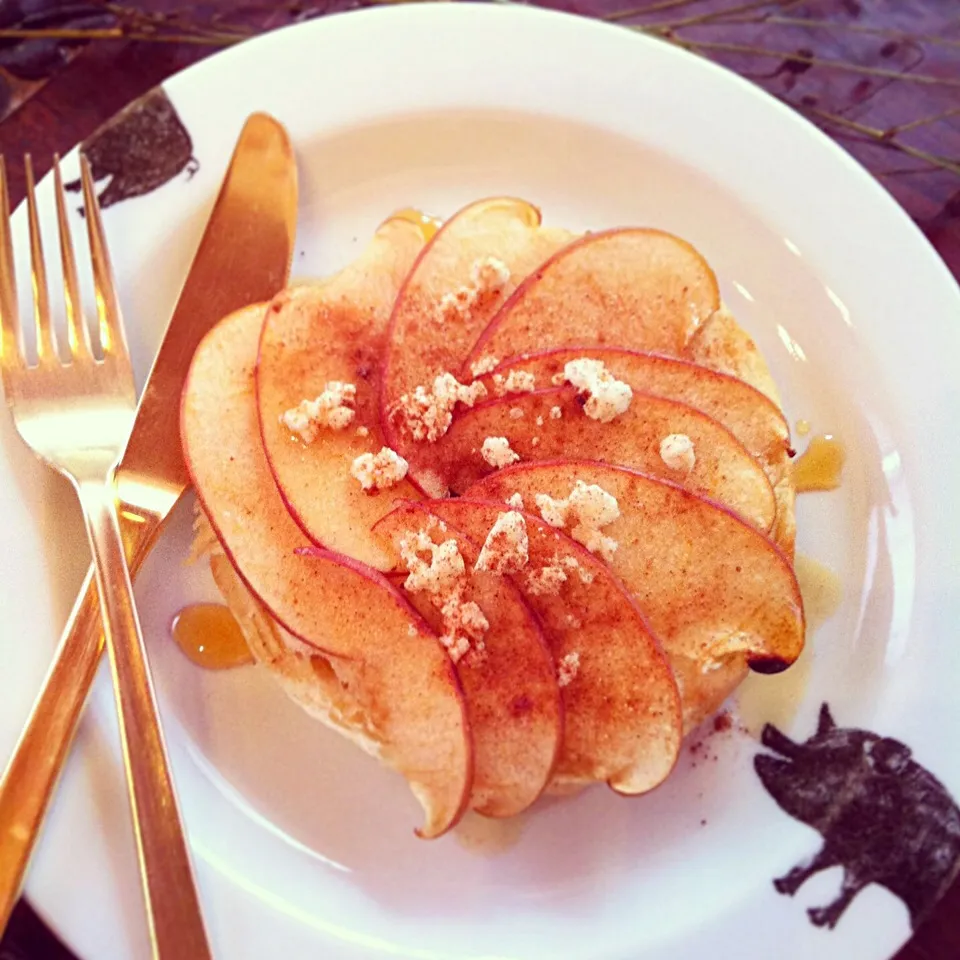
[0,157,210,960]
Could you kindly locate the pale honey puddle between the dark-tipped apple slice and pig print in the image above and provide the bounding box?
[736,555,843,737]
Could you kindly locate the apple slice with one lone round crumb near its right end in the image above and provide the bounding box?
[431,387,777,532]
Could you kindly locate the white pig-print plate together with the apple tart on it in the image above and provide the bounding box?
[0,4,960,960]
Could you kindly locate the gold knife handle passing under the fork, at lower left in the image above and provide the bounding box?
[0,515,160,935]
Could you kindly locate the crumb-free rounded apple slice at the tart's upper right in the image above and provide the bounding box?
[465,228,720,366]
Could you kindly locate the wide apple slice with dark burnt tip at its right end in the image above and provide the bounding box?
[465,460,804,729]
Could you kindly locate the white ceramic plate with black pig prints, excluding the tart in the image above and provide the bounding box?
[0,4,960,960]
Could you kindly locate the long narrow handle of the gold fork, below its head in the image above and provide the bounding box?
[78,482,211,960]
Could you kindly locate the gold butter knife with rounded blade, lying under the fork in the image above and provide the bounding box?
[0,113,297,936]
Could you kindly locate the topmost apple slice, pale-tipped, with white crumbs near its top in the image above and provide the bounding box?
[381,197,572,475]
